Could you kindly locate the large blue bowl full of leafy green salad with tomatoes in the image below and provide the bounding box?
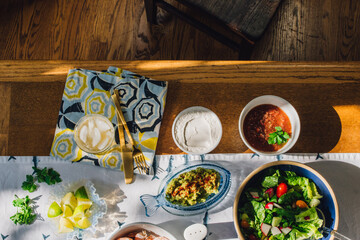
[234,161,339,240]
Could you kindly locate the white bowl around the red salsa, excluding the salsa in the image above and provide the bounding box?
[239,95,300,156]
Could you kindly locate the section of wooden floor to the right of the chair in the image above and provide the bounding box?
[252,0,360,61]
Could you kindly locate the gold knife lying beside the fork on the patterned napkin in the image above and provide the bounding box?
[111,95,134,184]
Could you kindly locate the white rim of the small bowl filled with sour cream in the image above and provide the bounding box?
[172,106,222,155]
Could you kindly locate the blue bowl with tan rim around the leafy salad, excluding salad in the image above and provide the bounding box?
[233,161,339,240]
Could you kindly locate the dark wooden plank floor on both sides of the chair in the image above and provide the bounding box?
[0,0,360,61]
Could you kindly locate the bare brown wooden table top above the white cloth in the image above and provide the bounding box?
[0,61,360,156]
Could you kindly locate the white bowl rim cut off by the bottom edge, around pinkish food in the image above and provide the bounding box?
[108,222,176,240]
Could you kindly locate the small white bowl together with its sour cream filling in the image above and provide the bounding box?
[172,106,222,155]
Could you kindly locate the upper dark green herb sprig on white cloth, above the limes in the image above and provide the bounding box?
[21,167,62,192]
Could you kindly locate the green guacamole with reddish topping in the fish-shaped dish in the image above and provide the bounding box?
[165,167,220,206]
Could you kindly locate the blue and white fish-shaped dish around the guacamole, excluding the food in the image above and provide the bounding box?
[140,161,231,217]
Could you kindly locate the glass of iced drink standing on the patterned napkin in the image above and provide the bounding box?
[74,114,115,153]
